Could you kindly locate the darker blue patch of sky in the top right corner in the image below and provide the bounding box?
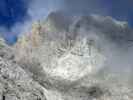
[103,0,133,26]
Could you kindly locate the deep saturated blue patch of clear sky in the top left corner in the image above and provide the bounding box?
[0,0,27,28]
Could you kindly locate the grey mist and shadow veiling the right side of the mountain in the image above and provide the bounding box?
[68,15,133,84]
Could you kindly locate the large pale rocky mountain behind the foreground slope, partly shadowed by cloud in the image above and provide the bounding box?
[13,12,133,100]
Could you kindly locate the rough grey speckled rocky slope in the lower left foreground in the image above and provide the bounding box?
[0,39,46,100]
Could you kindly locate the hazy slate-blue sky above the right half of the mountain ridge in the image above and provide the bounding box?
[63,0,133,26]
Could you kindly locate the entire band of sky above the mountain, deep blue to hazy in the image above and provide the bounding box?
[0,0,133,43]
